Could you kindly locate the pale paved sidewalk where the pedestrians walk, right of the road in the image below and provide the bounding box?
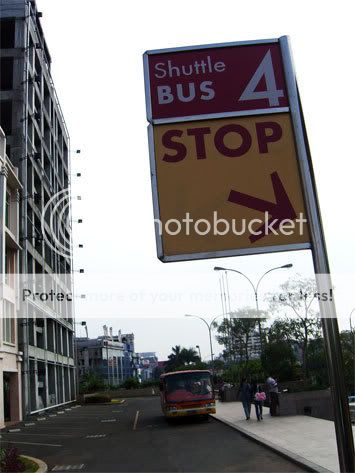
[213,402,355,472]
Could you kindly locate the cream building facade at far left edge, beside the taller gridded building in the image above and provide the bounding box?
[0,128,22,428]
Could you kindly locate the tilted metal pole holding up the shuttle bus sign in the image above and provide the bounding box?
[280,36,355,472]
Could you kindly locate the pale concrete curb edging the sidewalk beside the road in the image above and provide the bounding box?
[211,414,334,473]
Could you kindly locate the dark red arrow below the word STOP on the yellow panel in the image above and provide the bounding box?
[228,172,296,243]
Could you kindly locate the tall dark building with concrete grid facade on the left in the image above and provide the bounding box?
[0,0,76,415]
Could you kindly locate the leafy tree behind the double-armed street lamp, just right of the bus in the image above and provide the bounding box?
[215,307,261,363]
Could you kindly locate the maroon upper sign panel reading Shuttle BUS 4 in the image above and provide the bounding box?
[147,43,288,120]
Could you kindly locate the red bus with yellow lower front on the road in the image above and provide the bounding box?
[160,370,216,418]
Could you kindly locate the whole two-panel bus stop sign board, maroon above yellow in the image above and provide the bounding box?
[144,40,310,262]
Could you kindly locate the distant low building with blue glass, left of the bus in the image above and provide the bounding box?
[75,334,138,386]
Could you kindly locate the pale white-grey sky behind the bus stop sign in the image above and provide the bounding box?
[38,0,355,359]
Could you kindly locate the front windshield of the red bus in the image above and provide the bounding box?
[165,373,213,402]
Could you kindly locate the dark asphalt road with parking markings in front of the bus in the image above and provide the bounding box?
[1,398,306,472]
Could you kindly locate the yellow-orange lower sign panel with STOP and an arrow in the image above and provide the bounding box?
[153,113,310,261]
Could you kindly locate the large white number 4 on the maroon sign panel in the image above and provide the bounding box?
[239,49,284,107]
